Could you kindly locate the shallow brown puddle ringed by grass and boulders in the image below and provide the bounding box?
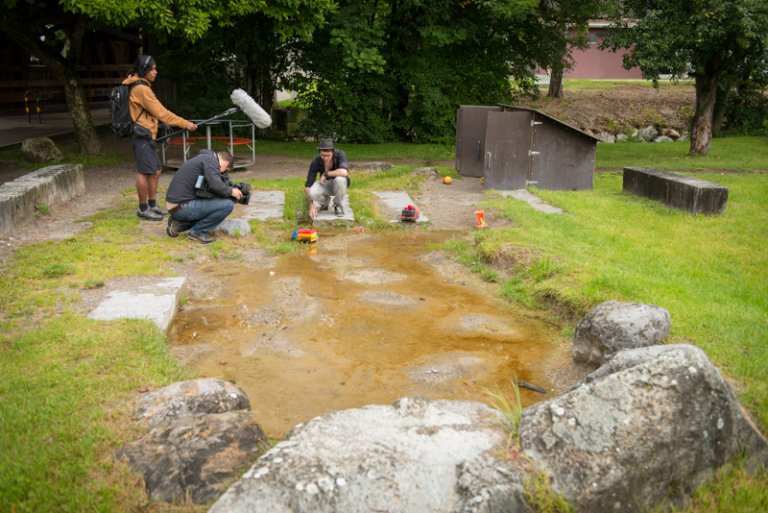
[170,230,557,436]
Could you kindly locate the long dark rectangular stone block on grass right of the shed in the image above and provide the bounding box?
[623,167,728,214]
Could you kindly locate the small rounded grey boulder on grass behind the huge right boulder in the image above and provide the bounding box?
[573,301,670,365]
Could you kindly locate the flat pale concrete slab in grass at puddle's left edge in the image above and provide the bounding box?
[88,277,186,331]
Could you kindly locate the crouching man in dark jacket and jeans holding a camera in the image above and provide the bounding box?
[165,150,250,244]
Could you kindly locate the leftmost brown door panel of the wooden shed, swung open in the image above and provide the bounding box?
[456,105,501,177]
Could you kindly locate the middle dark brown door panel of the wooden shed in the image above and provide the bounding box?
[484,111,533,190]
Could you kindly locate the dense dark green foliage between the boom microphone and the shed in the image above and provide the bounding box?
[290,0,547,142]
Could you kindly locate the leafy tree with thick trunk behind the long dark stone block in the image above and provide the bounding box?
[613,0,768,154]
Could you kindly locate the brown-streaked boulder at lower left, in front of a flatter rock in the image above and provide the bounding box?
[117,411,269,504]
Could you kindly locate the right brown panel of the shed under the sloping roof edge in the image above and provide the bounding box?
[530,112,596,191]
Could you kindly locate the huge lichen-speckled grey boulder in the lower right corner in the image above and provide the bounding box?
[520,345,768,513]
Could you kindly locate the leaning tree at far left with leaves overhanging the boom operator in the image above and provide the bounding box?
[0,0,332,154]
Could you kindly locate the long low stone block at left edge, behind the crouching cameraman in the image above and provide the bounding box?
[0,164,85,237]
